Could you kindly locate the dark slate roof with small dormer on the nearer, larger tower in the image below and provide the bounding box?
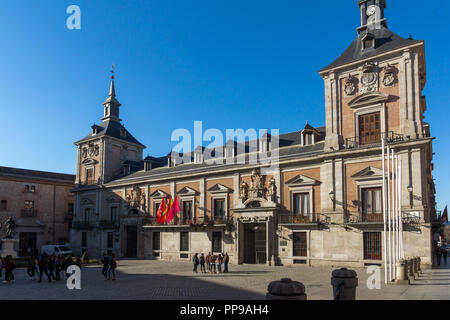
[319,26,422,72]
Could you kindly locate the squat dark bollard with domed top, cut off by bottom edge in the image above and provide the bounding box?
[266,278,307,300]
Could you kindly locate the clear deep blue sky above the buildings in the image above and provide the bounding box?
[0,0,450,209]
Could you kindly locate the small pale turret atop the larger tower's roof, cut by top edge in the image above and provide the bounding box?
[358,0,387,34]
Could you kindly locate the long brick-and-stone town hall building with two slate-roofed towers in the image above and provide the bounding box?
[71,0,435,266]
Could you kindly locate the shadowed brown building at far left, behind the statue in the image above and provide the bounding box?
[0,167,75,256]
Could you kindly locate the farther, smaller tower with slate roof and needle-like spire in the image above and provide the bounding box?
[75,71,145,187]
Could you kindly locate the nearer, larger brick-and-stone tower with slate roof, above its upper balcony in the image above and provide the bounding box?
[319,0,428,151]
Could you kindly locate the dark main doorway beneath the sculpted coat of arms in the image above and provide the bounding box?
[244,223,267,264]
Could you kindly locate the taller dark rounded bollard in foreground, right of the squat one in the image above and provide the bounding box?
[331,268,358,300]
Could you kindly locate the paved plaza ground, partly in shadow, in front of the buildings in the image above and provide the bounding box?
[0,260,450,300]
